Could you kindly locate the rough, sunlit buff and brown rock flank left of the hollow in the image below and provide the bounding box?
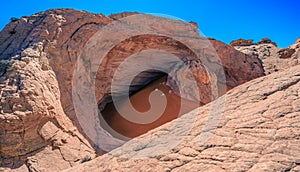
[0,10,101,171]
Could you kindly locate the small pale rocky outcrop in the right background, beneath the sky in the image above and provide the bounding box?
[234,39,300,75]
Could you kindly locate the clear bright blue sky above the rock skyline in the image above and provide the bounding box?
[0,0,300,47]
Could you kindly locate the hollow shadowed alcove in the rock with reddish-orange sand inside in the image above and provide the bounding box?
[95,35,213,146]
